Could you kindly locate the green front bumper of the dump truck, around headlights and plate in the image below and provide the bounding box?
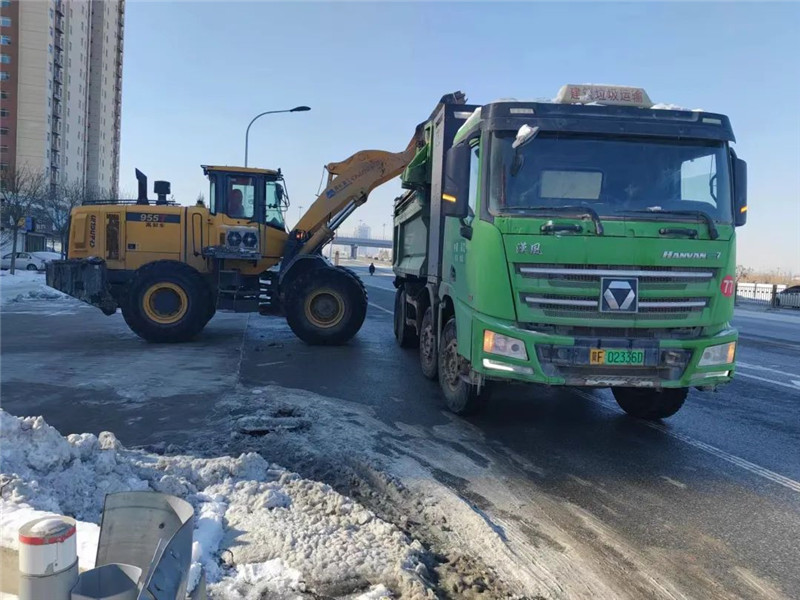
[471,313,738,388]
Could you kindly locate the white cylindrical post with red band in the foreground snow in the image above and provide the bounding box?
[19,516,78,600]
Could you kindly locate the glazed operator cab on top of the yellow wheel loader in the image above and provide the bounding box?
[203,165,289,231]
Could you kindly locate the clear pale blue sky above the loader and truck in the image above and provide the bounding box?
[120,0,800,274]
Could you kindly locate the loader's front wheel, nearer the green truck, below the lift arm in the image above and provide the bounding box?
[284,267,367,346]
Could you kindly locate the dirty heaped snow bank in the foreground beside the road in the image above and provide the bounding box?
[0,409,433,600]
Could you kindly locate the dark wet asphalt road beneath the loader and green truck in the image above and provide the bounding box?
[0,270,800,598]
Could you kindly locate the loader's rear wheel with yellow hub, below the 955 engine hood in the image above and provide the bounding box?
[122,261,211,343]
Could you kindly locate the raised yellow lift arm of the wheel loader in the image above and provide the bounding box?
[291,128,421,254]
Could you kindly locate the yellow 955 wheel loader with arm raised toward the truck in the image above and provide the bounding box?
[47,98,454,345]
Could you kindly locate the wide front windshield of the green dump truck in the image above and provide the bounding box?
[489,131,732,223]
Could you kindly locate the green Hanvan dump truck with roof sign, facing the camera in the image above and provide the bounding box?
[393,85,747,419]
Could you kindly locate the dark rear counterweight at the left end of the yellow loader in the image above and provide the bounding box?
[46,258,118,315]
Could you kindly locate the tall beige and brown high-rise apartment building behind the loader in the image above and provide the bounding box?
[0,0,125,194]
